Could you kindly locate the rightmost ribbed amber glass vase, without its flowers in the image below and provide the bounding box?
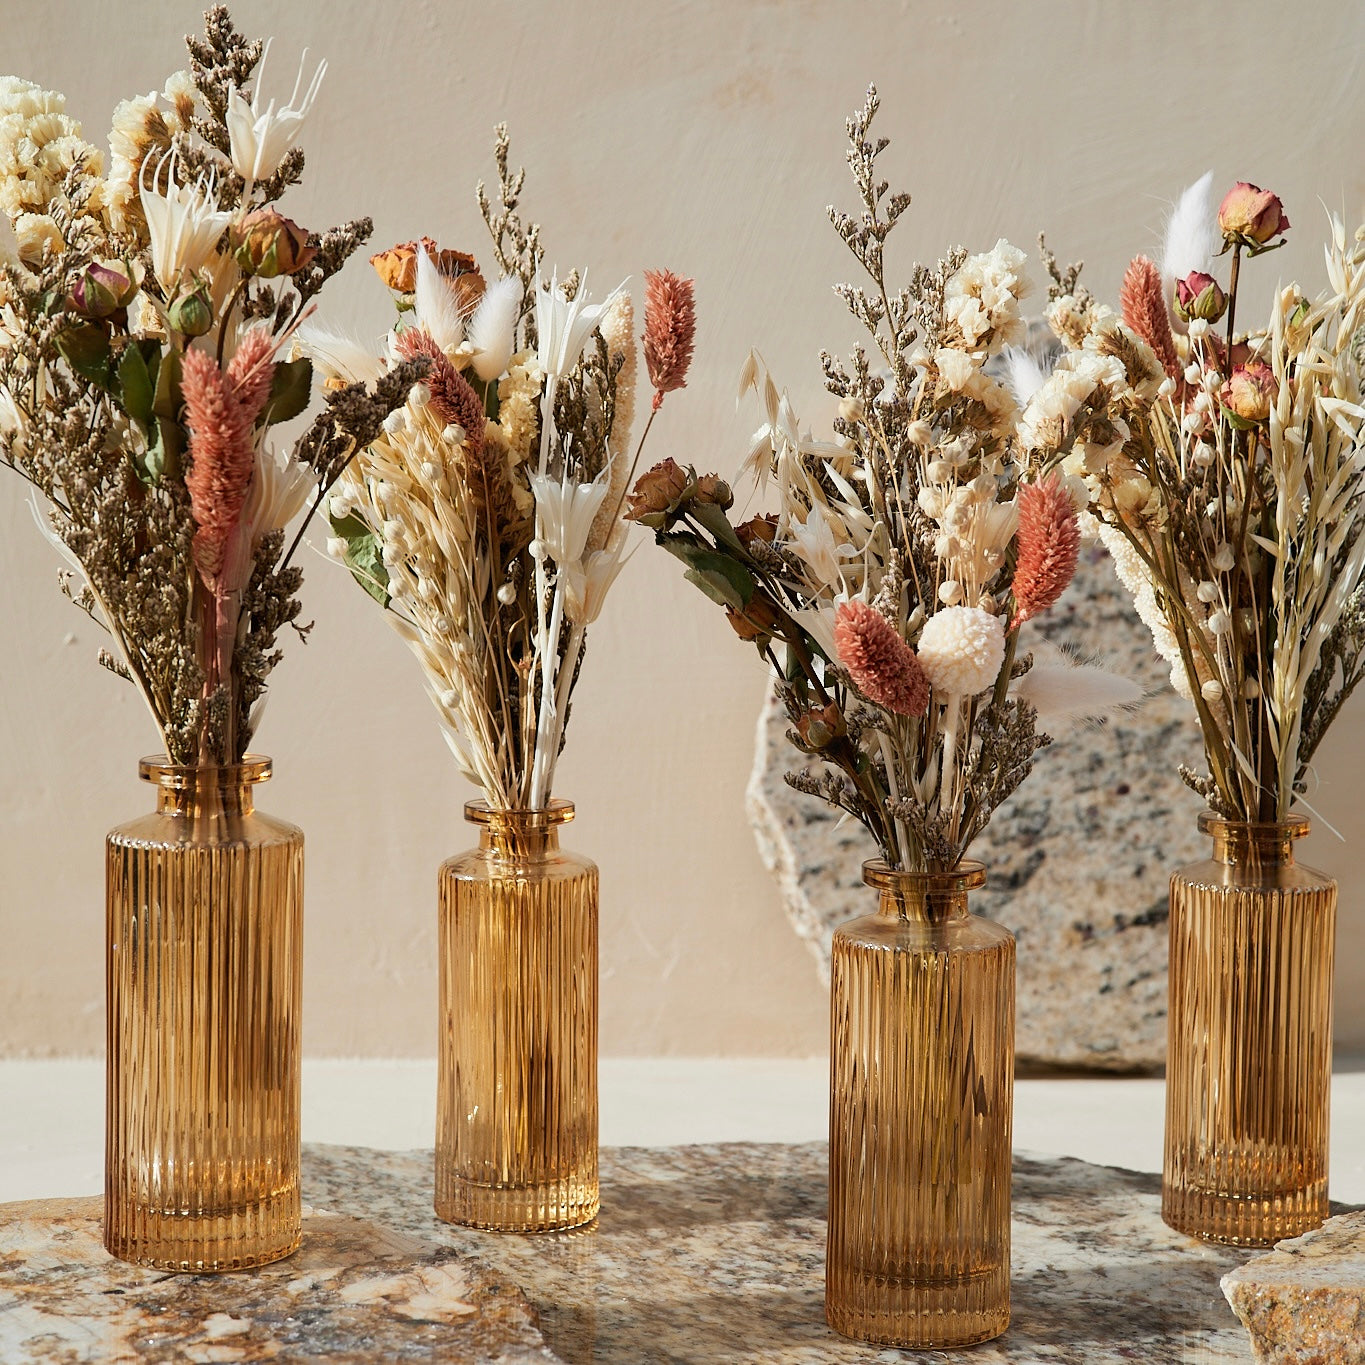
[1162,814,1336,1246]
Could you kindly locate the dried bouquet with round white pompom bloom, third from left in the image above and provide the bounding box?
[628,89,1137,871]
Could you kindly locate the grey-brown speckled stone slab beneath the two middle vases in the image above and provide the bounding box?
[304,1143,1252,1365]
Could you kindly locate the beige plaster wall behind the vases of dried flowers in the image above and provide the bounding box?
[0,0,1365,1055]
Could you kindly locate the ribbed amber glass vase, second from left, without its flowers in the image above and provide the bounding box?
[435,801,598,1233]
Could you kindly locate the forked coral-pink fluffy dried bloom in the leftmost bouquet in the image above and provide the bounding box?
[180,337,274,587]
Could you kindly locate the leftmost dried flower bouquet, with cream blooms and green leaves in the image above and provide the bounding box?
[0,5,425,764]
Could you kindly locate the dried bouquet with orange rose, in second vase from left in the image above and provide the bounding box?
[300,126,696,809]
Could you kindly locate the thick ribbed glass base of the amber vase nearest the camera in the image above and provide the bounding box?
[824,1265,1010,1350]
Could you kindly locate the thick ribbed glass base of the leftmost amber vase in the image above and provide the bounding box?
[104,1197,302,1275]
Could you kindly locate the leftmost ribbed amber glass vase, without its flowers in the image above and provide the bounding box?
[104,756,303,1271]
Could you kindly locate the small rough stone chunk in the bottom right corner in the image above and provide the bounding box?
[1223,1212,1365,1365]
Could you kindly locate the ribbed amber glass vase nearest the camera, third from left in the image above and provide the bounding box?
[824,863,1014,1347]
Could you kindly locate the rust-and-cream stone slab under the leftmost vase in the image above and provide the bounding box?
[0,1198,556,1365]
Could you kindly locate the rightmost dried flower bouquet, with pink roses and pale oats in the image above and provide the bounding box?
[1025,175,1365,822]
